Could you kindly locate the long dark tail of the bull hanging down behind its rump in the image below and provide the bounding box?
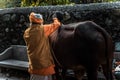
[89,22,114,80]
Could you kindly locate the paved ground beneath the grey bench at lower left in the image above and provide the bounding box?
[0,69,29,80]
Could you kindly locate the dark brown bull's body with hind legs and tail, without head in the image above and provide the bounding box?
[50,21,114,80]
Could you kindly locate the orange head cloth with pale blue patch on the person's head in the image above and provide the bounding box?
[29,12,43,24]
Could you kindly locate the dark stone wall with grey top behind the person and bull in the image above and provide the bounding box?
[0,2,120,52]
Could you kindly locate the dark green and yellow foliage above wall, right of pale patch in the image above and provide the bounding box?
[21,0,120,7]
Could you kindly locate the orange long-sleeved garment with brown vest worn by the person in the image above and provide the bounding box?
[24,18,60,75]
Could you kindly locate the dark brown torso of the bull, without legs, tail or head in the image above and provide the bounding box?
[51,21,113,66]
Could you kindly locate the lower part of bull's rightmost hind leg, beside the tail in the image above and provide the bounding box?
[102,63,113,80]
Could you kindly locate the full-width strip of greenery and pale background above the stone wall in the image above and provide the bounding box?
[0,0,120,8]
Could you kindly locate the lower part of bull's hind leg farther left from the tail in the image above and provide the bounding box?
[86,65,98,80]
